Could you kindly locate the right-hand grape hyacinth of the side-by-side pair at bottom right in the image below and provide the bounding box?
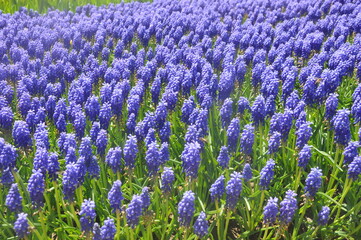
[279,190,297,225]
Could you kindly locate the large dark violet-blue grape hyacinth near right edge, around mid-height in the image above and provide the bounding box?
[332,109,351,145]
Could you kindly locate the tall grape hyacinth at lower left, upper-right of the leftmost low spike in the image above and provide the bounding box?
[28,169,45,208]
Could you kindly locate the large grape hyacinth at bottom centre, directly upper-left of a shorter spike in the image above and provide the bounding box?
[178,191,195,227]
